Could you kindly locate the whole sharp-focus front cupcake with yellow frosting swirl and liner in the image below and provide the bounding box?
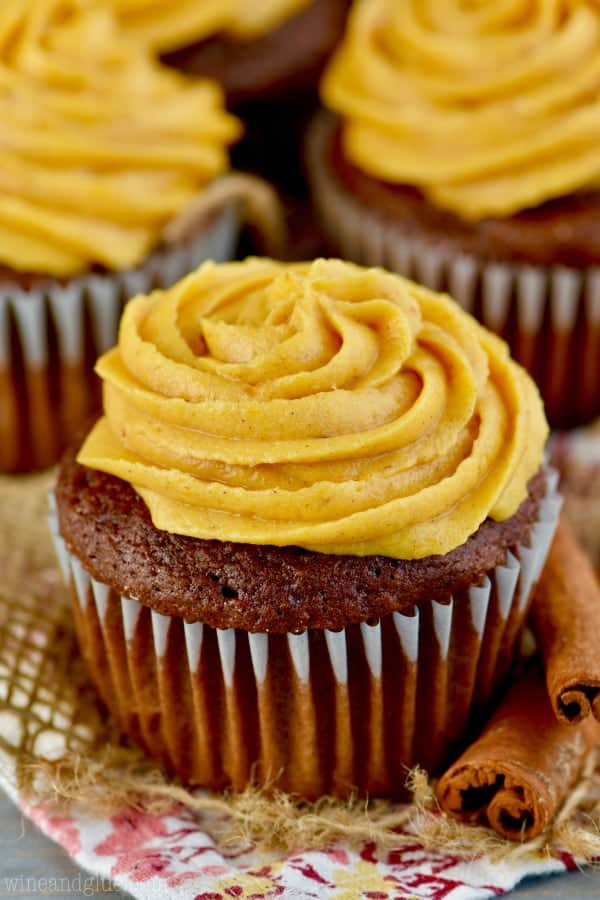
[51,259,560,797]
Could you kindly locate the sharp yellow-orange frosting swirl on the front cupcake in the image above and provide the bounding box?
[78,259,547,559]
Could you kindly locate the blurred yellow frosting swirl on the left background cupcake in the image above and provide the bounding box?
[0,0,240,277]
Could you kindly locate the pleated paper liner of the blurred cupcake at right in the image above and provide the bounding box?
[307,113,600,427]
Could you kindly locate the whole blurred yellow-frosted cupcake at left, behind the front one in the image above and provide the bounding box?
[0,0,240,472]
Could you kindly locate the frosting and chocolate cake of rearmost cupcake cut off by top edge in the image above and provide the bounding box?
[111,0,348,105]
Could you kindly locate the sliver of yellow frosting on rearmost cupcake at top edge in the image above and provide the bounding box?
[110,0,311,53]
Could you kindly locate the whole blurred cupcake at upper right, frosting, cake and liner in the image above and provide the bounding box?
[309,0,600,427]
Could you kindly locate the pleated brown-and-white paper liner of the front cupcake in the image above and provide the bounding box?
[50,470,561,797]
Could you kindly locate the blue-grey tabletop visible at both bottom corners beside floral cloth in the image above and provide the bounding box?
[0,793,600,900]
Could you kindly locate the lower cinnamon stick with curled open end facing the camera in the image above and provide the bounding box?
[437,664,600,841]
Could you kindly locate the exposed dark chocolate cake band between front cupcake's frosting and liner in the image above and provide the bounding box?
[56,449,546,633]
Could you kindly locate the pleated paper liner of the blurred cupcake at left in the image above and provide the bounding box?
[0,204,239,472]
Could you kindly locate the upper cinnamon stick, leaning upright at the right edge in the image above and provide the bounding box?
[531,516,600,723]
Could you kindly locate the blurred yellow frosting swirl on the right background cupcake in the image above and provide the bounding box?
[322,0,600,220]
